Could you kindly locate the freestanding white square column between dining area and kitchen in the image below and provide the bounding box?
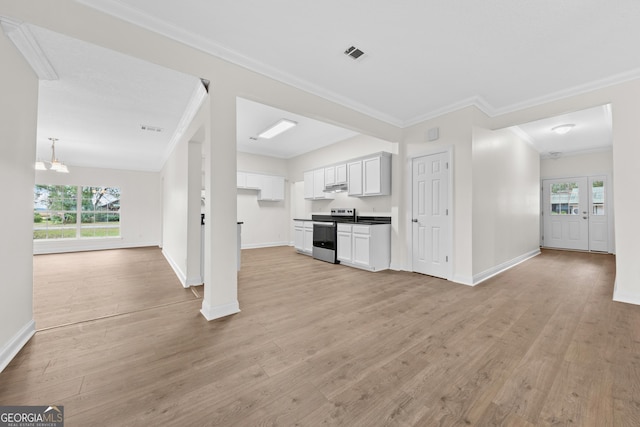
[200,88,240,320]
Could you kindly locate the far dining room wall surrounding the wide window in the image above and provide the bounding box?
[31,165,161,254]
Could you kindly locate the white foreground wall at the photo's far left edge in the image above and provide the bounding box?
[0,26,38,371]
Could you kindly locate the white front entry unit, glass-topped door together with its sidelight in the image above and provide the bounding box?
[542,177,608,252]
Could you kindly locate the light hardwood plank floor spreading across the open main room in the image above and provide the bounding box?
[0,247,640,427]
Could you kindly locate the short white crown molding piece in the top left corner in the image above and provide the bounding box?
[0,16,58,80]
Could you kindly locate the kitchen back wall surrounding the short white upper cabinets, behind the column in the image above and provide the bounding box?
[237,152,291,249]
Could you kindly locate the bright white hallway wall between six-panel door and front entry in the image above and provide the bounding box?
[472,127,540,284]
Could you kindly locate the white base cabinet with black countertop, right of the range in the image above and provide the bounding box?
[337,224,391,271]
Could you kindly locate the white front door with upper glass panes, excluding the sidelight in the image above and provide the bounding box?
[542,177,590,251]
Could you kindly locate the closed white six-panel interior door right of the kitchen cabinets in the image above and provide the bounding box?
[411,153,451,278]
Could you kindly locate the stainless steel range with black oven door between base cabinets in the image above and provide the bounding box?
[311,208,356,264]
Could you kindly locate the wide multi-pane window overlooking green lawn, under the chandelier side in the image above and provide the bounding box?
[33,185,120,240]
